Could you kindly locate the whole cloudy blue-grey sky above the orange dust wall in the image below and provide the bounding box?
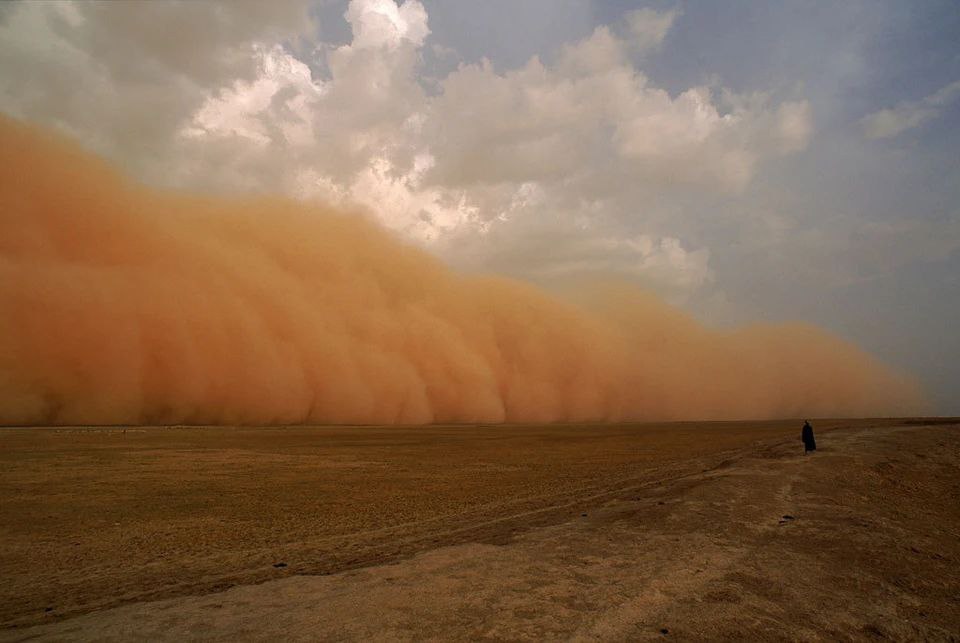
[0,0,960,414]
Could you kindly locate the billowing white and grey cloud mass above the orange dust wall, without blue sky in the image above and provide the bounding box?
[0,0,812,304]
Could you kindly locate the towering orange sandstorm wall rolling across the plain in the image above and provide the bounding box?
[0,118,922,423]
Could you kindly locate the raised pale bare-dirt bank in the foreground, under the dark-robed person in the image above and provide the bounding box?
[0,426,960,640]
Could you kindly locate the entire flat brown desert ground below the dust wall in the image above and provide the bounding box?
[0,421,960,640]
